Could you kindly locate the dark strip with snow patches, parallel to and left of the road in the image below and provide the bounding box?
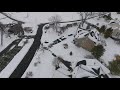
[0,39,22,72]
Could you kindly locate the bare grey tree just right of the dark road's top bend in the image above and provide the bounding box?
[49,15,62,33]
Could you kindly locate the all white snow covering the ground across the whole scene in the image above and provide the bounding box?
[0,12,120,78]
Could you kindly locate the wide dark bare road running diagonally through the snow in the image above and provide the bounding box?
[10,24,45,78]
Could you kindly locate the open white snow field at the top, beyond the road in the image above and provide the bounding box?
[0,12,79,35]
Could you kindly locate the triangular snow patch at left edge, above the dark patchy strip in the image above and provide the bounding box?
[0,32,18,52]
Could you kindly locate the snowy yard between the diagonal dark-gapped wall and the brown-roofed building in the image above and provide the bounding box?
[50,37,91,62]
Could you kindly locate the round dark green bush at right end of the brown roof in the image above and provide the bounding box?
[91,45,105,59]
